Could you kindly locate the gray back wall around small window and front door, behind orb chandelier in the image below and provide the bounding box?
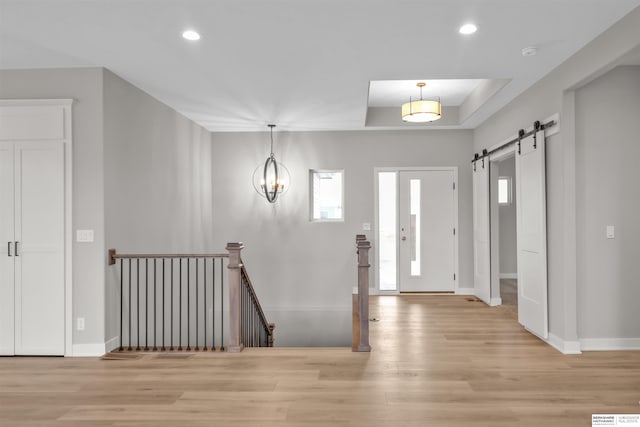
[212,127,473,346]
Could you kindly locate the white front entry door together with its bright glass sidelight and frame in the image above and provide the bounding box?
[375,167,458,294]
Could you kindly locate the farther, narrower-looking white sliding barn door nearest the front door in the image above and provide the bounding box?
[472,159,491,304]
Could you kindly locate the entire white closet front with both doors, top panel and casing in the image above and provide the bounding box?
[0,99,72,355]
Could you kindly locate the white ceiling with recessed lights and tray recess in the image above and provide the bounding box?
[0,0,640,131]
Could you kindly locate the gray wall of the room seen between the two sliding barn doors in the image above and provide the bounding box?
[498,157,518,275]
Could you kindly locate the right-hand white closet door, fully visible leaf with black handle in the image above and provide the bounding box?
[14,142,65,355]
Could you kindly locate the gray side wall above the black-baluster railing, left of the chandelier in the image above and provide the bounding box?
[104,70,215,340]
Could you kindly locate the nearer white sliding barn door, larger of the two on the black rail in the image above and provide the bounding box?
[516,131,549,339]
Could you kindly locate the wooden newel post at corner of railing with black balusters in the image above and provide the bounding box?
[226,242,244,353]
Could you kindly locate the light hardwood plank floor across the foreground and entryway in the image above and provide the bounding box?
[0,295,640,427]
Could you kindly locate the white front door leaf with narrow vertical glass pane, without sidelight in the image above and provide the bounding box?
[398,170,455,292]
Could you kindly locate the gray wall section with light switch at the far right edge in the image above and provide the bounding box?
[576,66,640,339]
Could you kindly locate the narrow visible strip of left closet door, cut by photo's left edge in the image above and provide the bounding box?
[0,142,15,355]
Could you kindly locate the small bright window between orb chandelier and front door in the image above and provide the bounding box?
[309,169,344,221]
